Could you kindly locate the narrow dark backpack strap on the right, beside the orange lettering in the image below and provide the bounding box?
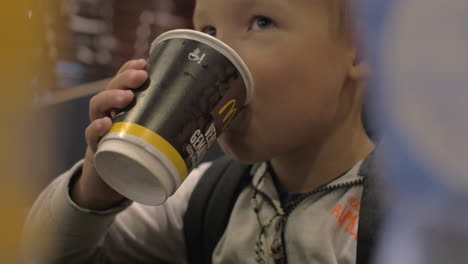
[356,154,383,264]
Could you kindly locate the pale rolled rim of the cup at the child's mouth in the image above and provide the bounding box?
[150,29,254,105]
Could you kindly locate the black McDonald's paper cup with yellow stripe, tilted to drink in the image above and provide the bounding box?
[94,30,253,205]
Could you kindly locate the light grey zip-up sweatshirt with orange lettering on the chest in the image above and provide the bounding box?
[23,161,363,264]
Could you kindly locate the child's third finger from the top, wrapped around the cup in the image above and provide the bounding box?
[89,90,134,121]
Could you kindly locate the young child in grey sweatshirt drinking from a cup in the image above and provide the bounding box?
[26,0,374,264]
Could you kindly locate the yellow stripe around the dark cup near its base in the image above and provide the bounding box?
[109,122,188,182]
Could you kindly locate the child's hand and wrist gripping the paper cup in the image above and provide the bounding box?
[71,60,148,210]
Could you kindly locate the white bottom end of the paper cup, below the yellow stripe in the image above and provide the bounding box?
[94,139,175,205]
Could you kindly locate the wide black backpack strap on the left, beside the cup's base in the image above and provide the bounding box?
[184,157,250,263]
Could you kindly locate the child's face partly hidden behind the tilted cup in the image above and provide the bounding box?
[194,0,352,162]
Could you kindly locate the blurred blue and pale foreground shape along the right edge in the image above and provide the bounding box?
[357,0,468,264]
